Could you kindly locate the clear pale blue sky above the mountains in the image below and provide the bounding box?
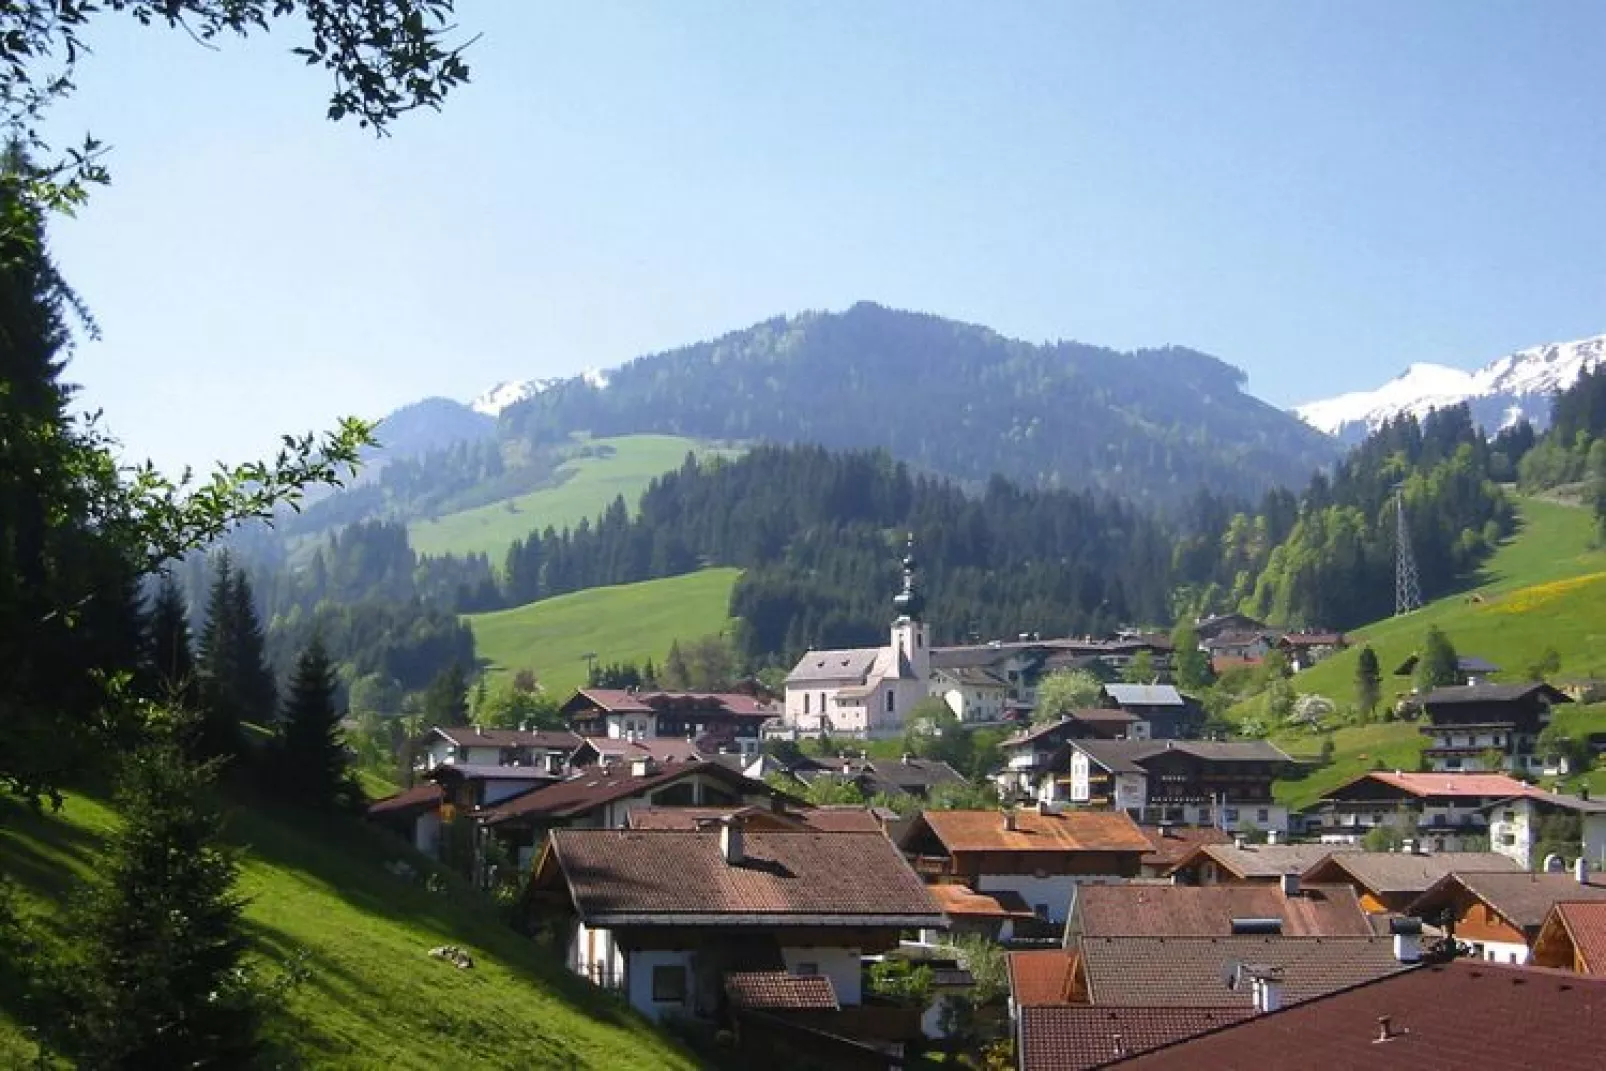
[51,0,1606,470]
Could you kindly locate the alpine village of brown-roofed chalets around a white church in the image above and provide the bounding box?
[368,552,1606,1071]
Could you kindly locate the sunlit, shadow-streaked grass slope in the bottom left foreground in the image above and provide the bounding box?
[0,795,694,1071]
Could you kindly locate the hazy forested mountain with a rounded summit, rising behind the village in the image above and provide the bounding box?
[499,303,1338,506]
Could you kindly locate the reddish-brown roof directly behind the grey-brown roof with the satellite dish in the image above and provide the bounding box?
[1076,883,1372,938]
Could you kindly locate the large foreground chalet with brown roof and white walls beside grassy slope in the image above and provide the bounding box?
[530,822,944,1021]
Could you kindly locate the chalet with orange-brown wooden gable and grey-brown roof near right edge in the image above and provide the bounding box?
[1408,861,1606,963]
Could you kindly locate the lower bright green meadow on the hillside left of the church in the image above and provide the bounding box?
[464,568,740,697]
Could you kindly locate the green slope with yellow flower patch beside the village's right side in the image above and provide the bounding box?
[1237,499,1606,806]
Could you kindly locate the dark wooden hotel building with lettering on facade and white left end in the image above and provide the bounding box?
[1058,740,1294,832]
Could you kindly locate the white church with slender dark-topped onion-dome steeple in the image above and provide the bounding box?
[782,540,931,739]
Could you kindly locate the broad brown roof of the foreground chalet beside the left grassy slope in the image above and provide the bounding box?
[536,829,943,928]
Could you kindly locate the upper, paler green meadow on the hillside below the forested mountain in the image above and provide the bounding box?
[408,435,735,568]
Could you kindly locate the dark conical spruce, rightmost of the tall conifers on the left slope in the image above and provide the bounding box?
[279,634,352,808]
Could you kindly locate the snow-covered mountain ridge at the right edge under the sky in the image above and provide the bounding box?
[1294,334,1606,443]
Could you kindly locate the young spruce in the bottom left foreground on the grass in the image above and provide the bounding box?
[61,743,260,1068]
